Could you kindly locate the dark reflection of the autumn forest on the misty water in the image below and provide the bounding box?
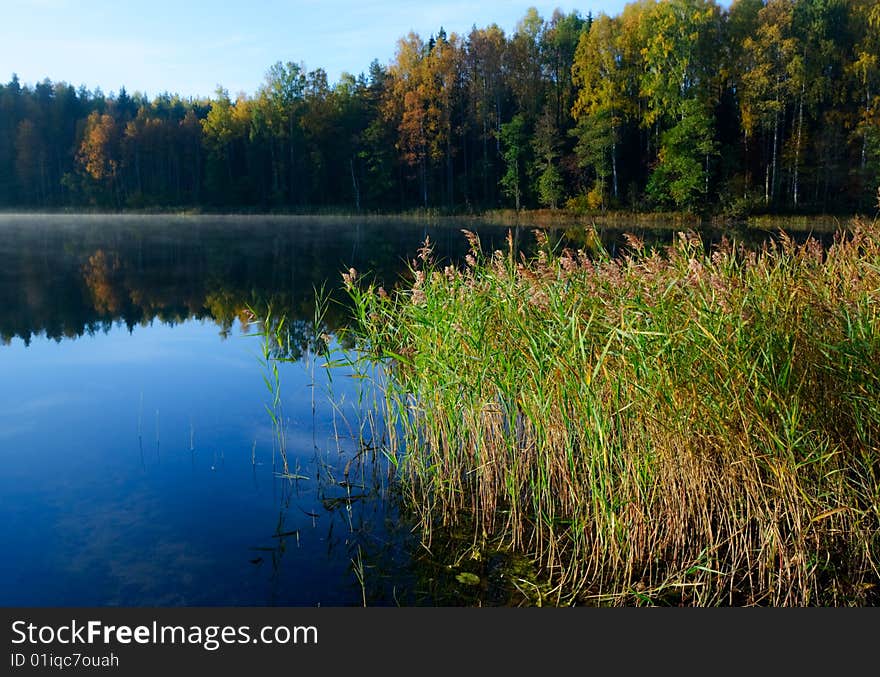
[0,215,501,343]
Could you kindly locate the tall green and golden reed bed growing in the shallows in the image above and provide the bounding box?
[344,222,880,606]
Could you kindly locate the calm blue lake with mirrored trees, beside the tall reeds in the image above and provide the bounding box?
[0,215,828,606]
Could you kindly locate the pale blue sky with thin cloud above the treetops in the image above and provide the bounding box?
[0,0,656,98]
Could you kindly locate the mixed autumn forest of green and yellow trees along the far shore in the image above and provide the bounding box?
[0,0,880,216]
